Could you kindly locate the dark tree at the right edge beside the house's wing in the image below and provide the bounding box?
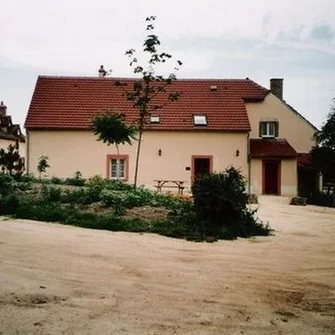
[310,99,335,182]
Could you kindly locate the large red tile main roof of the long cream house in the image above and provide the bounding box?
[25,76,269,131]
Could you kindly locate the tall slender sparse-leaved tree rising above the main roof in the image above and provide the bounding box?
[115,16,182,187]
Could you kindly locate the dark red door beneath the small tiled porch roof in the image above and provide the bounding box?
[263,160,280,195]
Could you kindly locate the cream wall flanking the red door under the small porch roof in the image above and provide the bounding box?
[250,159,298,196]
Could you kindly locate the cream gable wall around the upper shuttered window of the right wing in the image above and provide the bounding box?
[247,93,315,153]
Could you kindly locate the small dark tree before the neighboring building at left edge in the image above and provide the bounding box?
[0,142,24,176]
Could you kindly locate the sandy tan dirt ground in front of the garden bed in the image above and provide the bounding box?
[0,197,335,335]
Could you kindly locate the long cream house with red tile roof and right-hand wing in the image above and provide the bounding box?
[25,70,316,196]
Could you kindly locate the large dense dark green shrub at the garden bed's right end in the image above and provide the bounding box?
[192,168,270,239]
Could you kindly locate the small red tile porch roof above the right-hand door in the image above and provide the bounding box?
[250,138,298,158]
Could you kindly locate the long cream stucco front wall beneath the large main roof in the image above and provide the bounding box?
[27,130,248,187]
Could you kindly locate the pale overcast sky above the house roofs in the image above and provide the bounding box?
[0,0,335,130]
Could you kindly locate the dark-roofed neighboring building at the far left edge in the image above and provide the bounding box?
[0,101,26,157]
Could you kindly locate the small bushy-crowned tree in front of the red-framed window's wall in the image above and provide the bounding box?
[91,112,137,155]
